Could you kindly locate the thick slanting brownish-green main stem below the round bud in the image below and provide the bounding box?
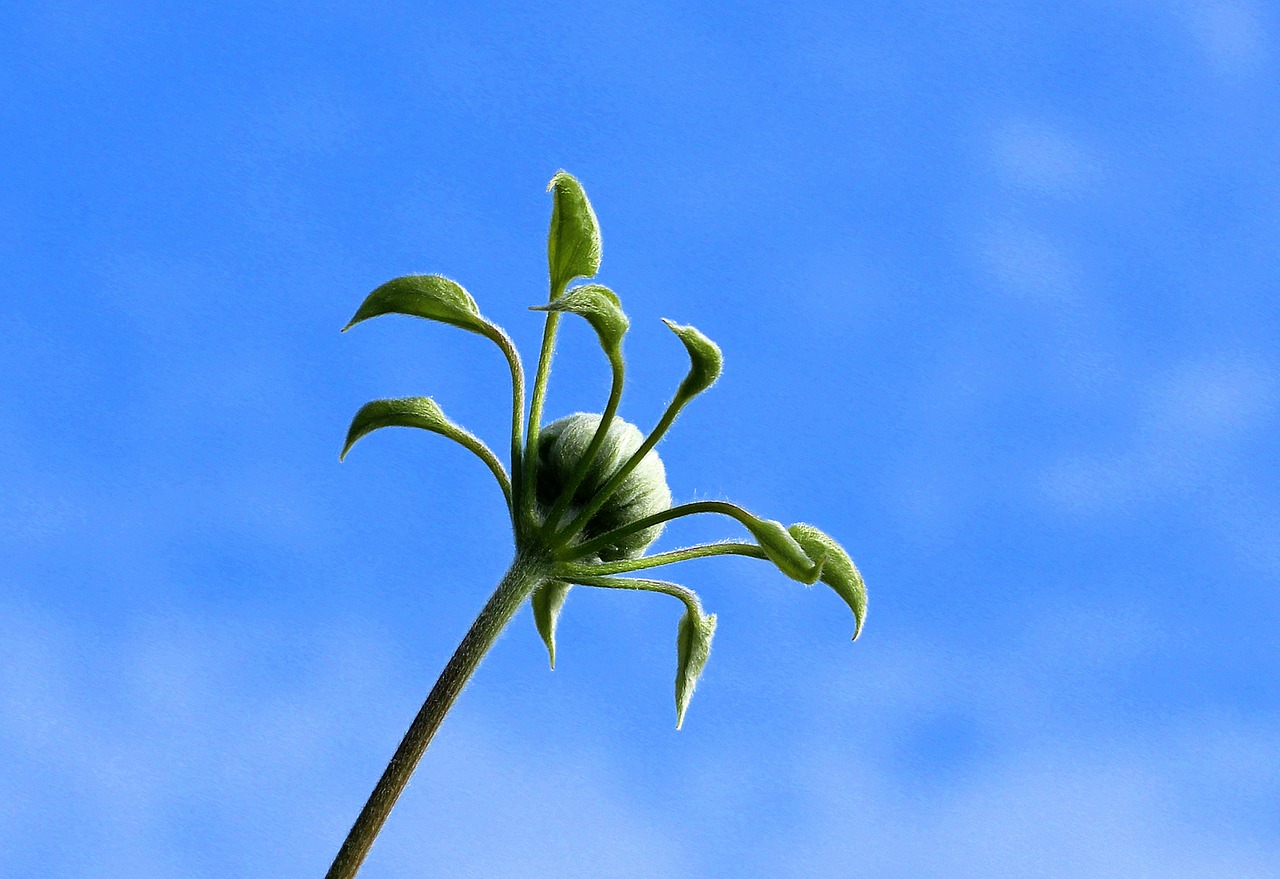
[325,554,549,879]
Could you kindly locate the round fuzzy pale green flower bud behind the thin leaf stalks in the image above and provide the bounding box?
[536,412,671,562]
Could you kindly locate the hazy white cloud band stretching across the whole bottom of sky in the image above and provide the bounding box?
[0,588,1280,879]
